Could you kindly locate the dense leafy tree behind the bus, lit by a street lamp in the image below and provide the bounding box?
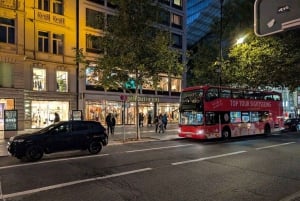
[190,0,300,89]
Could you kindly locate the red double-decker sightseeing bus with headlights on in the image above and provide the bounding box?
[179,86,283,139]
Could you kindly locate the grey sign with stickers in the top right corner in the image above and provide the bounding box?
[254,0,300,36]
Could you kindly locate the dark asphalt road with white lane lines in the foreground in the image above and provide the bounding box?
[0,133,300,201]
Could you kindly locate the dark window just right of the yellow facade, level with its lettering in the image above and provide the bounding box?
[86,8,104,29]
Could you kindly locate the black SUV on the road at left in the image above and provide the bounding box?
[8,121,108,161]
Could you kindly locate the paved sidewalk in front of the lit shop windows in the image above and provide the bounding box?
[0,124,179,157]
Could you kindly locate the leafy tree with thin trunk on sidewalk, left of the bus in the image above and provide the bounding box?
[76,0,184,138]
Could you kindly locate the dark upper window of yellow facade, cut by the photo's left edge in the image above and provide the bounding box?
[0,17,15,44]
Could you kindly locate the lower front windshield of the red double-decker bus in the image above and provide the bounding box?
[179,111,203,125]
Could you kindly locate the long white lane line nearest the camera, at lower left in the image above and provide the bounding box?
[2,168,152,199]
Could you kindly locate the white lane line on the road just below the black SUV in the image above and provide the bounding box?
[0,154,109,170]
